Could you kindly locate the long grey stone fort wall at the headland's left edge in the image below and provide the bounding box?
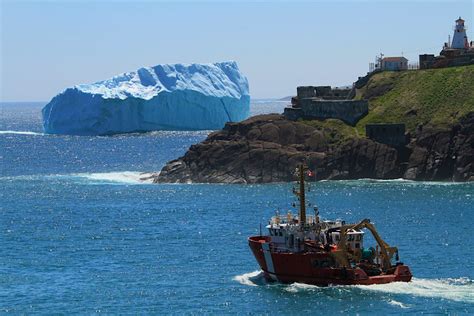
[284,98,369,126]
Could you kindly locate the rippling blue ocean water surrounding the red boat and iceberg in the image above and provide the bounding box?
[0,100,474,315]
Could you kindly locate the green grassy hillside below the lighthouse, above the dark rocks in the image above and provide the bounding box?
[356,65,474,135]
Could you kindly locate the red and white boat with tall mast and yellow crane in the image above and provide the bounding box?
[248,164,412,286]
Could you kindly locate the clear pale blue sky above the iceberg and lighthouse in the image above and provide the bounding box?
[0,0,474,102]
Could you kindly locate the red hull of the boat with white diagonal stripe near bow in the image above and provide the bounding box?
[249,236,412,286]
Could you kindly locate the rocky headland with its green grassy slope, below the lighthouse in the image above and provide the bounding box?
[155,65,474,183]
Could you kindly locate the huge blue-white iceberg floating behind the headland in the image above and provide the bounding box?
[42,61,250,135]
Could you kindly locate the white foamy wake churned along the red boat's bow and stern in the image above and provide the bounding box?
[233,271,474,308]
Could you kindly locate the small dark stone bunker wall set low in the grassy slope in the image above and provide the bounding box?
[365,124,407,147]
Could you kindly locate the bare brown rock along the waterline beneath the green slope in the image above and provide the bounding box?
[154,112,474,183]
